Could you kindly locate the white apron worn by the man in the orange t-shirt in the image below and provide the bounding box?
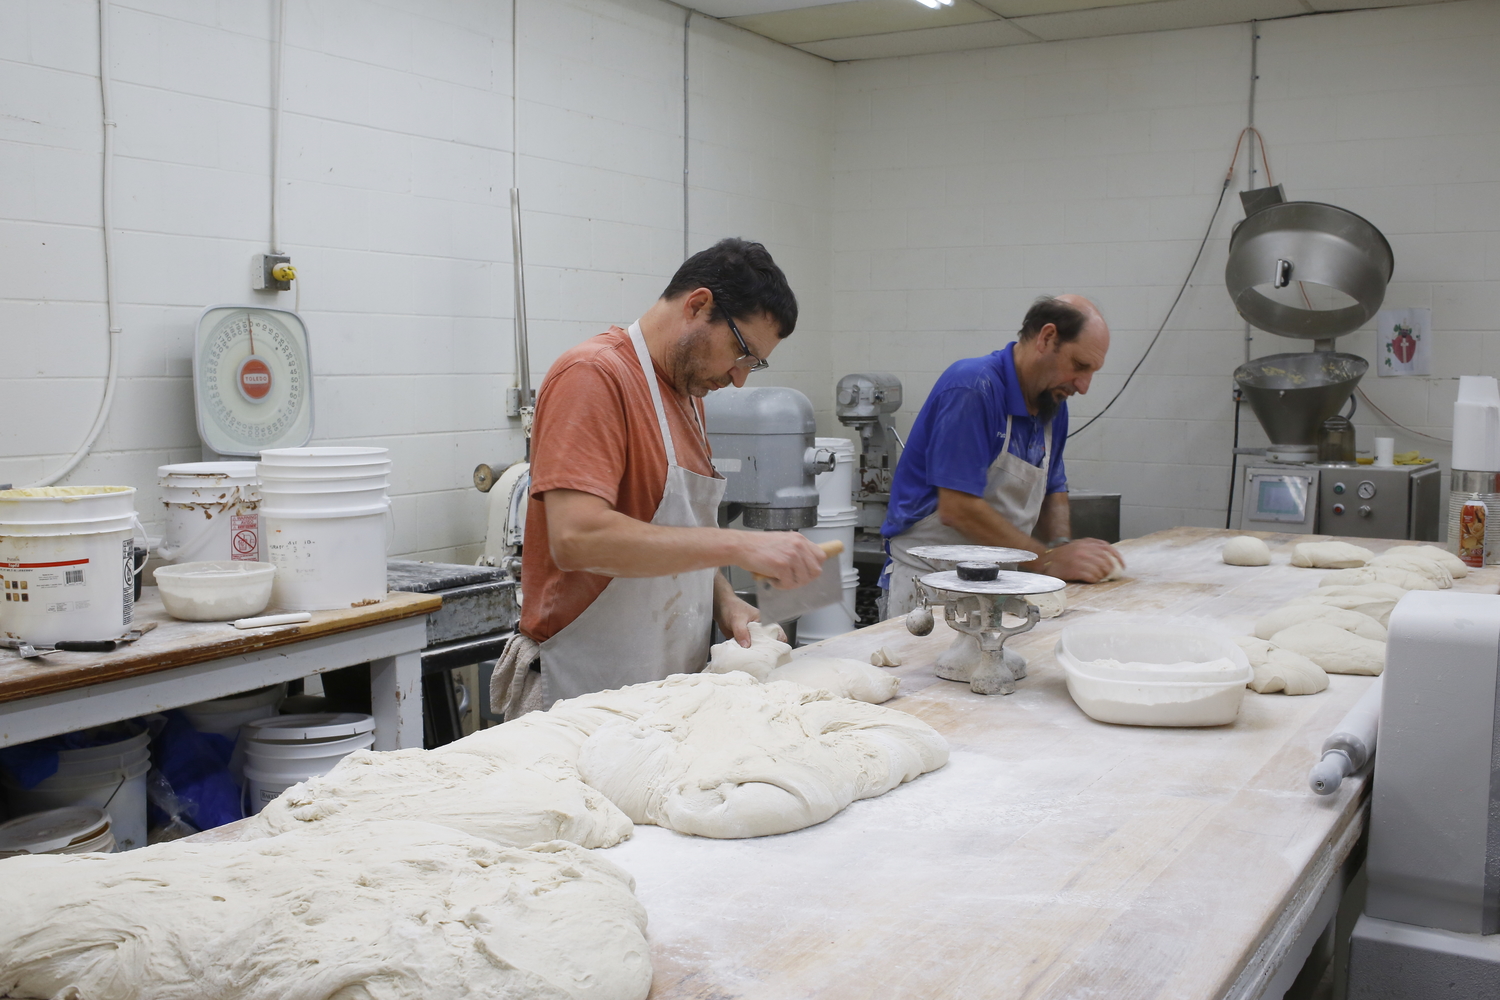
[542,322,725,708]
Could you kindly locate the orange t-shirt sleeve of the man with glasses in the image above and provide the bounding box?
[531,361,629,507]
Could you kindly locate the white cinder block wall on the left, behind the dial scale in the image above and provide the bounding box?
[0,0,833,561]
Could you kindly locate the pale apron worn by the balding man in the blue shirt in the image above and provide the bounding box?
[885,415,1052,618]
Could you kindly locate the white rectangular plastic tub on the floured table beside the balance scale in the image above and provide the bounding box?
[1055,624,1254,726]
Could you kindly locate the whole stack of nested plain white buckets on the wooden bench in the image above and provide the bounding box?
[258,447,390,612]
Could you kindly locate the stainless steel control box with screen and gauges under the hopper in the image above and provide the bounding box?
[1241,462,1442,541]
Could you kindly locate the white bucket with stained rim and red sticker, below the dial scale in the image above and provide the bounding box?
[156,462,261,562]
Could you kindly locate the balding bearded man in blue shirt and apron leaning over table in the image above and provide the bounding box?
[881,295,1125,616]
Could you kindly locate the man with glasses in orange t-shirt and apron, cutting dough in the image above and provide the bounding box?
[521,238,824,706]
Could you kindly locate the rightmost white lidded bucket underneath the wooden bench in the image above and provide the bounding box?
[240,712,375,814]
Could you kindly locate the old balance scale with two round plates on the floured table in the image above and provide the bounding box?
[906,546,1067,694]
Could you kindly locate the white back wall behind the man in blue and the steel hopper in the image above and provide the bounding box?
[833,0,1500,537]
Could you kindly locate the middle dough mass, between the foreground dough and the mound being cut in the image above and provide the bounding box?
[240,746,633,847]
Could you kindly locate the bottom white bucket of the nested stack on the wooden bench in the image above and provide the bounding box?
[263,501,390,612]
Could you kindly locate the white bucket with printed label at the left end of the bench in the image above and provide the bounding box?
[0,486,146,643]
